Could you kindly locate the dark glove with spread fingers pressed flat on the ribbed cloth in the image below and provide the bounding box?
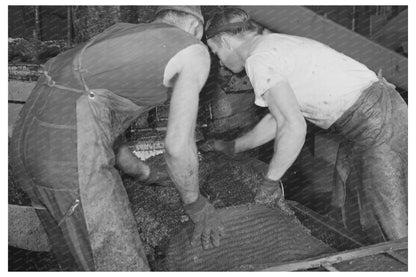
[184,195,224,249]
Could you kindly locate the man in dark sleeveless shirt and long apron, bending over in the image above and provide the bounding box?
[10,6,222,271]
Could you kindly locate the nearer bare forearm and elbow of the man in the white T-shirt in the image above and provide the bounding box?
[263,82,306,180]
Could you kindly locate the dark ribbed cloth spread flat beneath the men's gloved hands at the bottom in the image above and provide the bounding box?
[165,205,334,271]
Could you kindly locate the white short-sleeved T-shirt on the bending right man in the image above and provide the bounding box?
[245,34,378,129]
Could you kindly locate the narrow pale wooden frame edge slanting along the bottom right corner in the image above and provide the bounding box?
[263,238,408,271]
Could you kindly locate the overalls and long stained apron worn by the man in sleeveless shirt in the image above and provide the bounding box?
[12,29,149,271]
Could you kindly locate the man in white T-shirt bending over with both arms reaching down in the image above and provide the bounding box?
[202,5,407,239]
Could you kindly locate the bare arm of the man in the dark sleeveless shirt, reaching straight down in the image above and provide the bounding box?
[165,45,210,204]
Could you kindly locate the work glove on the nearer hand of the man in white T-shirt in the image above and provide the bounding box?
[254,176,294,215]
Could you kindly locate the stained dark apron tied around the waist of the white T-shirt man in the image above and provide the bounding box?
[331,74,408,241]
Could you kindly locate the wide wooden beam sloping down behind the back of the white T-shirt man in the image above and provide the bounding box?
[240,6,408,90]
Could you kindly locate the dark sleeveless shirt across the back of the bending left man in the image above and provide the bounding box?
[46,23,201,106]
